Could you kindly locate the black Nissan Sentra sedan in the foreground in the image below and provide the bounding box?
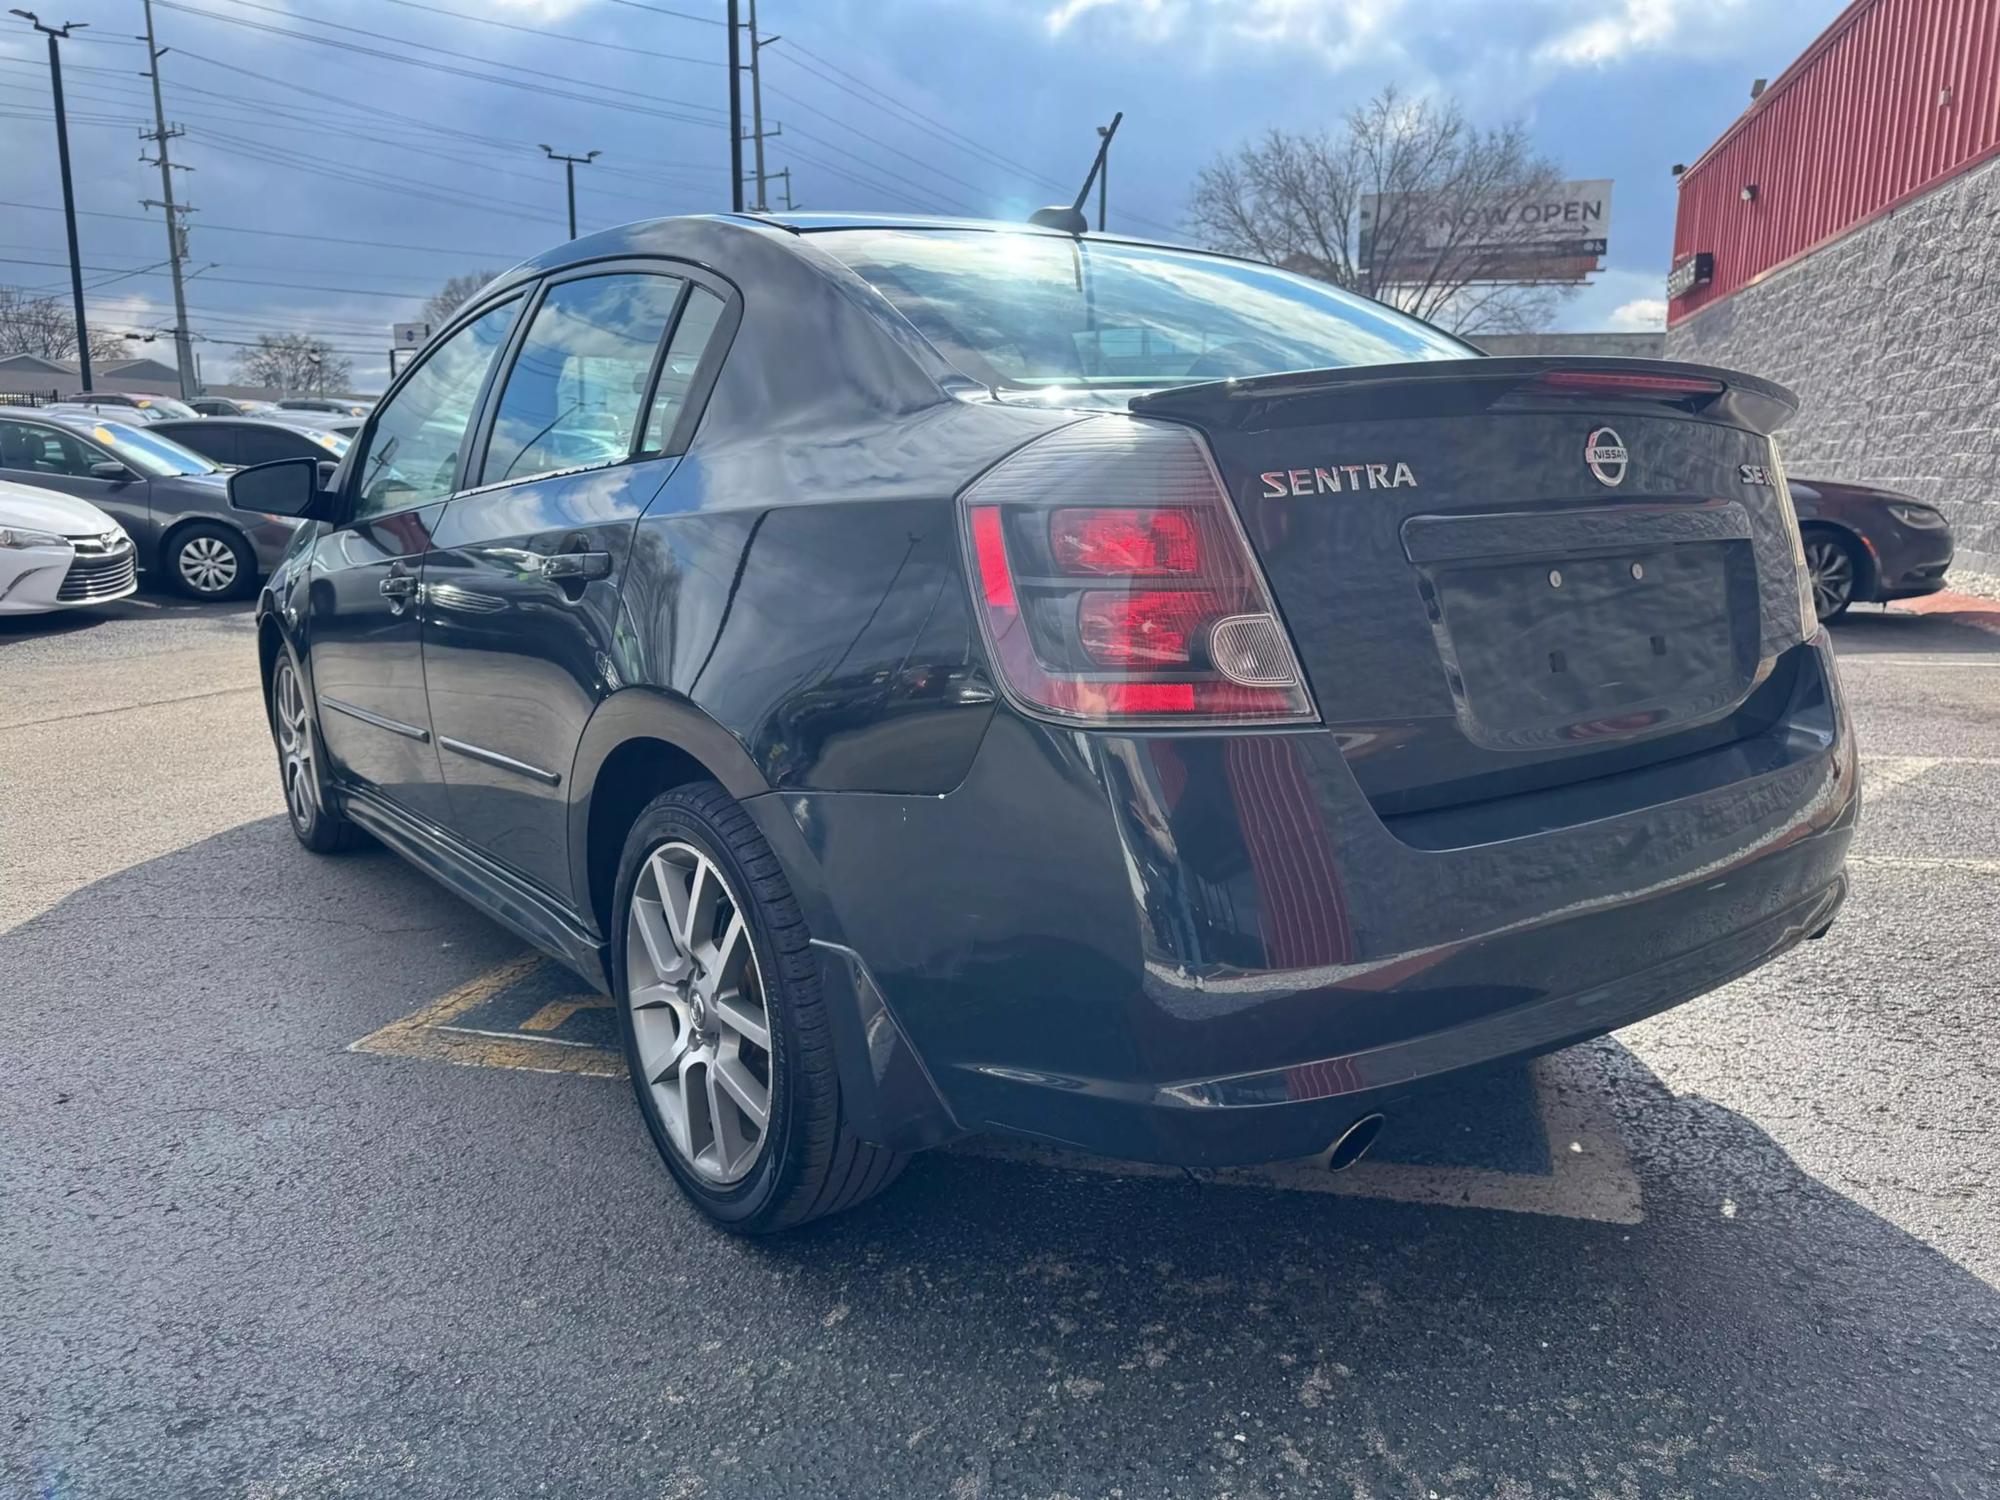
[230,214,1858,1232]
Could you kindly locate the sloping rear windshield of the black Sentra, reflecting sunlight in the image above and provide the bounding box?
[814,228,1478,388]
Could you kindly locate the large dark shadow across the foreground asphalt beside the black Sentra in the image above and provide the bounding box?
[15,818,2000,1500]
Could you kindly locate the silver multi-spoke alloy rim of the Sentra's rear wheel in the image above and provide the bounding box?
[626,840,772,1184]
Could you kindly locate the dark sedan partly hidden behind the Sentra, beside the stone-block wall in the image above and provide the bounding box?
[1792,480,1952,620]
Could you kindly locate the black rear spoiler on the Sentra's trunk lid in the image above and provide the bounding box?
[1132,354,1798,434]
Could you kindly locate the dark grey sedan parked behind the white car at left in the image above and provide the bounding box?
[0,408,298,598]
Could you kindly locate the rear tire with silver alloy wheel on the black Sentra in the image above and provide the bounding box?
[612,782,906,1234]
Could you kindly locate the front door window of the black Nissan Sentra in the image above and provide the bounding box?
[354,298,520,520]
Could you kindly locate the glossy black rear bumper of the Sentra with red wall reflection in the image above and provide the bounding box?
[750,636,1858,1164]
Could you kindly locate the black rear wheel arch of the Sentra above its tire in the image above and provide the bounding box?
[570,688,770,934]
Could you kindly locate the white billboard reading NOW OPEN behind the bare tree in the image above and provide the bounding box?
[1360,178,1612,282]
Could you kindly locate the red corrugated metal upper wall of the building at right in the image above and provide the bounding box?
[1668,0,2000,322]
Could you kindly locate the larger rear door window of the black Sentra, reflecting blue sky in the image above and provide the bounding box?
[480,272,682,484]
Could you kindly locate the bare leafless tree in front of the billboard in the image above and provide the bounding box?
[1188,88,1574,334]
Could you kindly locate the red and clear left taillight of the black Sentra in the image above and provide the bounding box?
[960,416,1314,726]
